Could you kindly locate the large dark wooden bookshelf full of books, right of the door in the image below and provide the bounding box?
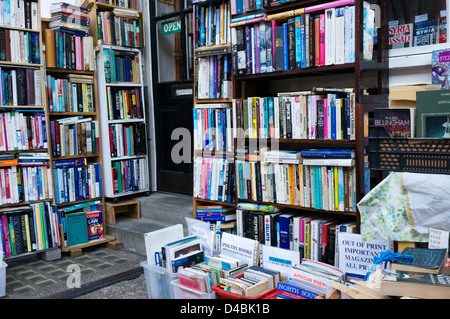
[190,0,388,276]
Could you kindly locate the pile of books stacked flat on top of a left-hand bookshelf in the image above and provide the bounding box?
[48,2,90,35]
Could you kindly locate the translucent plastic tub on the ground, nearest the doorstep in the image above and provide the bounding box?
[141,261,178,299]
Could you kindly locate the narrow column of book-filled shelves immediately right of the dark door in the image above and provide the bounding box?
[192,1,236,218]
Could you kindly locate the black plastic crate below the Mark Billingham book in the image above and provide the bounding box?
[369,126,450,174]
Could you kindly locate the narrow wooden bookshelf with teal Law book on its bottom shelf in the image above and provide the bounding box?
[42,3,115,254]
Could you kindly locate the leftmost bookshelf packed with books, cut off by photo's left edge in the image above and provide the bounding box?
[0,1,60,260]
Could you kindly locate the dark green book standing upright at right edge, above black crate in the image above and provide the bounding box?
[416,90,450,138]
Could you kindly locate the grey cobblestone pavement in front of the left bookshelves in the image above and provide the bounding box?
[3,247,146,299]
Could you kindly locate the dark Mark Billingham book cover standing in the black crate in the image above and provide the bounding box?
[373,108,415,138]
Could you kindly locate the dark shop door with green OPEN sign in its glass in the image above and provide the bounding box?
[149,0,194,195]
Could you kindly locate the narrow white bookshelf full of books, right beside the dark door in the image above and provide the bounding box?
[89,2,150,202]
